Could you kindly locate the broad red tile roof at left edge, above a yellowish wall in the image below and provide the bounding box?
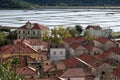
[1,43,37,54]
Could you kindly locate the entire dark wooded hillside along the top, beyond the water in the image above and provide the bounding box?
[0,0,120,9]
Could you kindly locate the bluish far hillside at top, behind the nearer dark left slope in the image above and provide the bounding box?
[24,0,120,6]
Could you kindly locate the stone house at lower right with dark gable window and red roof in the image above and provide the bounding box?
[77,54,113,80]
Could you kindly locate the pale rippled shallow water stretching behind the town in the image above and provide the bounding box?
[0,9,120,31]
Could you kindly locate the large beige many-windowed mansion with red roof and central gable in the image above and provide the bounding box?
[17,21,48,39]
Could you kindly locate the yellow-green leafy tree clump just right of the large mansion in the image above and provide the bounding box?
[43,27,71,43]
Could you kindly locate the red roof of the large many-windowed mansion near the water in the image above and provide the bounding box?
[18,22,48,30]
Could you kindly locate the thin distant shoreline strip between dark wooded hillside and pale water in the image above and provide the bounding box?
[0,6,120,10]
